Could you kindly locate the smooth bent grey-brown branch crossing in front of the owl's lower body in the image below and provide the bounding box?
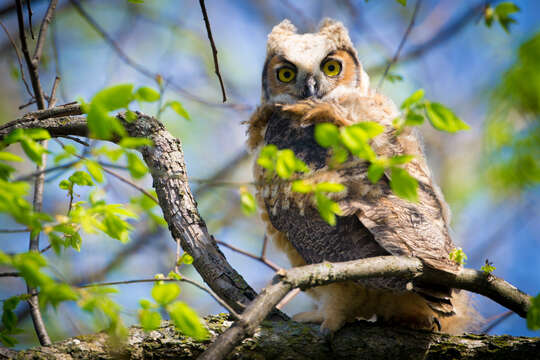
[198,256,531,360]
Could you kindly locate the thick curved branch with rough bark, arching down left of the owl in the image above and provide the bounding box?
[0,106,256,312]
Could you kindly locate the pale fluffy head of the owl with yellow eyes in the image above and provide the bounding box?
[262,19,369,103]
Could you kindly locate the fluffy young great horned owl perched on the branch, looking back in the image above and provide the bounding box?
[248,20,471,333]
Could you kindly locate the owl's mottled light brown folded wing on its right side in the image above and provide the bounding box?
[340,95,459,272]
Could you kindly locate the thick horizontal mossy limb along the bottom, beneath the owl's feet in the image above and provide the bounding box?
[0,315,540,360]
